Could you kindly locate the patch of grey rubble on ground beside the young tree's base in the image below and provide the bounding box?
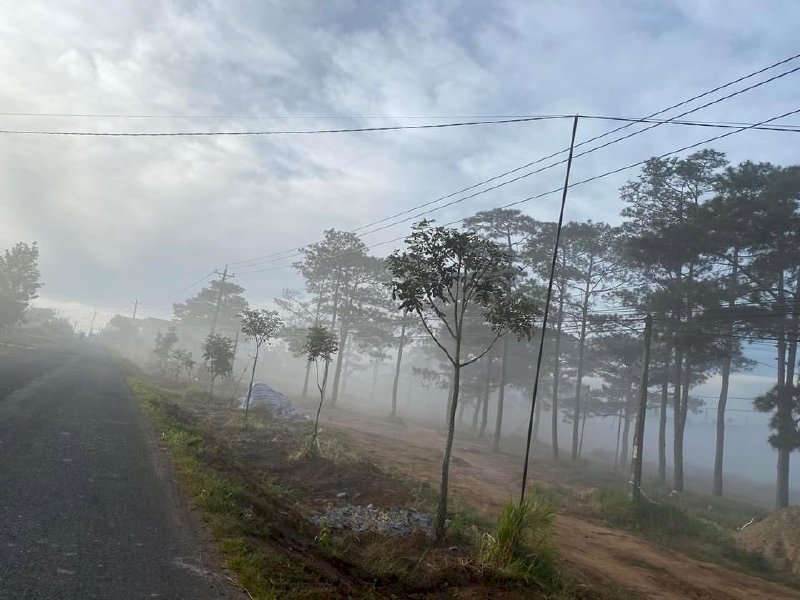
[311,504,433,536]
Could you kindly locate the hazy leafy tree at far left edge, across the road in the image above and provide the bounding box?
[0,242,42,331]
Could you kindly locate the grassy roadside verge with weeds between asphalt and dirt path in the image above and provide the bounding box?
[129,374,625,599]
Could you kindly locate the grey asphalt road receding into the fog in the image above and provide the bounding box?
[0,343,240,600]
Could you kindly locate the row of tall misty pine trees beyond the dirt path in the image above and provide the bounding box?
[277,150,800,506]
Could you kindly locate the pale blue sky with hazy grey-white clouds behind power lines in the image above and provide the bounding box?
[0,0,800,332]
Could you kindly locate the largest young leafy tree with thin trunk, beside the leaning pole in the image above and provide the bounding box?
[387,221,536,542]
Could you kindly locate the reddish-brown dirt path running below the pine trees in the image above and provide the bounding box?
[318,410,800,600]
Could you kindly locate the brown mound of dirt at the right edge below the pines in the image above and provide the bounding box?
[736,506,800,573]
